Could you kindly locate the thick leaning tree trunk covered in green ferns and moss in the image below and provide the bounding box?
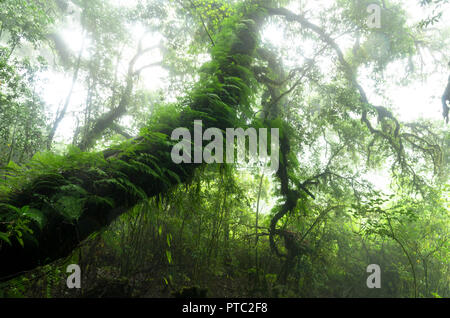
[0,6,264,280]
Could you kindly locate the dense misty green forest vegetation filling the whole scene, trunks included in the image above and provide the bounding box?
[0,0,450,297]
